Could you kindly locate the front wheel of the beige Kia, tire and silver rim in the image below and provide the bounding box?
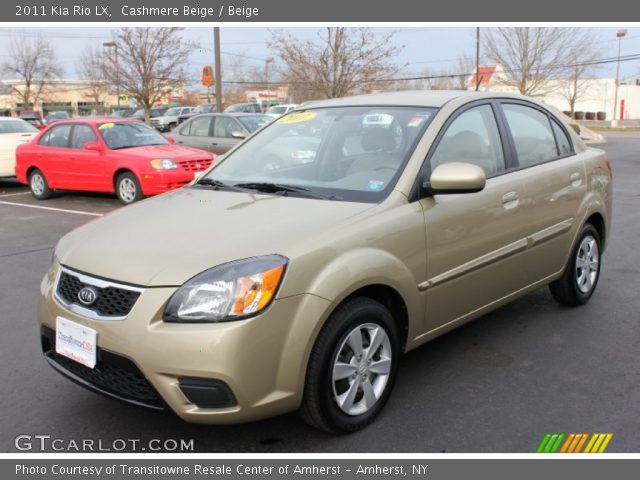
[300,297,401,433]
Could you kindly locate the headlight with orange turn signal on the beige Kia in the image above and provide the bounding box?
[164,255,287,322]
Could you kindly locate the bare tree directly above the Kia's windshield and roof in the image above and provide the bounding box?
[268,27,402,98]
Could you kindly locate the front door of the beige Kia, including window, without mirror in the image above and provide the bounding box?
[419,99,526,331]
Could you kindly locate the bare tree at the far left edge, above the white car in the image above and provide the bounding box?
[1,36,62,108]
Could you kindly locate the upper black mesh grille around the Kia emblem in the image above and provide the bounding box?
[56,271,140,317]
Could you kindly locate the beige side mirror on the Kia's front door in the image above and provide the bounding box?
[424,163,487,194]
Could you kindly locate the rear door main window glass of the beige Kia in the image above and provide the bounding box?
[502,104,558,167]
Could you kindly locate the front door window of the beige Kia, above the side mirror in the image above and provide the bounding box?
[431,105,505,176]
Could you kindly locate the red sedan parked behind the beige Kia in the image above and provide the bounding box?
[16,118,214,204]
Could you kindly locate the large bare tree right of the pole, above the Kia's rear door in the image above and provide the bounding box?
[484,27,591,95]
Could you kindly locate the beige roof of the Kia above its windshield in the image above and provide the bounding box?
[298,90,526,109]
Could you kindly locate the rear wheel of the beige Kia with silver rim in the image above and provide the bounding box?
[549,223,601,306]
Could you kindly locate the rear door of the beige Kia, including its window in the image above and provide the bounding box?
[501,100,587,284]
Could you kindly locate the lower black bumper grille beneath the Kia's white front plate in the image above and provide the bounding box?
[42,327,164,410]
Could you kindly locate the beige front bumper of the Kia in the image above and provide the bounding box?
[38,265,331,424]
